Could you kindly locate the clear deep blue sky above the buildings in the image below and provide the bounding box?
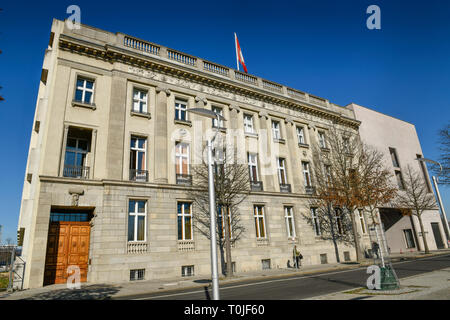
[0,0,450,244]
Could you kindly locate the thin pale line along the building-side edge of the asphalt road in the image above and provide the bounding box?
[132,254,449,300]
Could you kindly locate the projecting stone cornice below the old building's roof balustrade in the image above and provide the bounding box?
[59,34,361,130]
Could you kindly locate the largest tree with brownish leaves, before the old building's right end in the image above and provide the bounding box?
[306,125,396,261]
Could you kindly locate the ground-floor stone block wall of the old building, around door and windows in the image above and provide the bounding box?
[27,181,362,286]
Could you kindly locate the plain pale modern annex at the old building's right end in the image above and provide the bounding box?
[347,103,448,253]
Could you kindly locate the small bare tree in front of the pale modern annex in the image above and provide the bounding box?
[395,165,437,253]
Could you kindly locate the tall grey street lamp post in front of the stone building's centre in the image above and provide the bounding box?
[187,108,226,300]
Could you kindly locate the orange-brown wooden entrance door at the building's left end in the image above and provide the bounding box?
[44,221,90,285]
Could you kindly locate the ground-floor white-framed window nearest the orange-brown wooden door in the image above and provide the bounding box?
[128,200,147,242]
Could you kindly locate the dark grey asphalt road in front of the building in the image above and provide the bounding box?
[121,254,450,300]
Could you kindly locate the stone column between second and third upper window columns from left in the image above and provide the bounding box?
[154,87,170,183]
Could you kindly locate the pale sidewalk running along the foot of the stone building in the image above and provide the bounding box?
[0,249,450,300]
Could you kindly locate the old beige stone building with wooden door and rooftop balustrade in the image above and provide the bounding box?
[19,20,442,288]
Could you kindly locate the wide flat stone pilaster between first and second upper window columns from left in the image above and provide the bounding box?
[106,75,127,180]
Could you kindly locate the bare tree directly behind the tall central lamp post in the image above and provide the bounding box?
[192,144,250,277]
